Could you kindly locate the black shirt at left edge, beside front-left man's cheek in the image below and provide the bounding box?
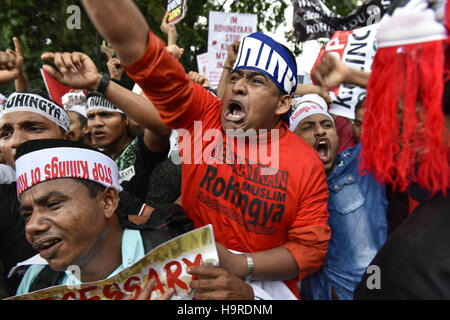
[0,182,38,274]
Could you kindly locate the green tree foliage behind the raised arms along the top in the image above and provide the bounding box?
[0,0,357,92]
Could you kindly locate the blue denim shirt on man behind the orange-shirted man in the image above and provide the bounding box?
[300,144,388,300]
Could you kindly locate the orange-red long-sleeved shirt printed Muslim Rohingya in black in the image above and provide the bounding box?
[126,32,331,296]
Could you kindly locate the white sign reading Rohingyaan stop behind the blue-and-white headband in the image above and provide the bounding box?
[208,11,258,88]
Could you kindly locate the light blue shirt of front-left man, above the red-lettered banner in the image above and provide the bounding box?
[17,229,145,295]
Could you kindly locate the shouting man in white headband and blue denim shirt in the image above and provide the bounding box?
[290,95,387,300]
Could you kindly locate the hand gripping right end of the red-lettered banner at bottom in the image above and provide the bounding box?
[187,266,254,300]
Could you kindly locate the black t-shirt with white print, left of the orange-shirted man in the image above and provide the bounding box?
[114,134,169,202]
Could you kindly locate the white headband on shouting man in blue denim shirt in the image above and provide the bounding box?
[289,94,334,132]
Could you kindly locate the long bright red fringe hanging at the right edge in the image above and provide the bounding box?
[361,41,450,193]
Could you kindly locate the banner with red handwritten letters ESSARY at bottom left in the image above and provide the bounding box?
[5,225,219,300]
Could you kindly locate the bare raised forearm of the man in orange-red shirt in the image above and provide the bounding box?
[82,0,148,66]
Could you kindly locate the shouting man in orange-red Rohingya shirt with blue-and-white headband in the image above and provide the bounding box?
[48,0,330,299]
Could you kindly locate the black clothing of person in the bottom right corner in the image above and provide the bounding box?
[354,194,450,300]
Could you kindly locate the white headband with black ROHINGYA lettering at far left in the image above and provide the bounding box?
[0,92,70,132]
